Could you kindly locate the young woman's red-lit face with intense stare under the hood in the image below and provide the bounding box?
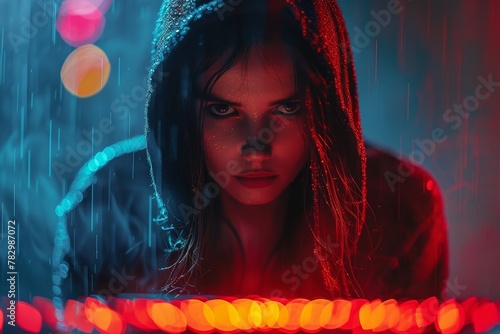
[198,45,309,205]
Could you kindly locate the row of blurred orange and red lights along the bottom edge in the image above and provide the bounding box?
[0,297,500,333]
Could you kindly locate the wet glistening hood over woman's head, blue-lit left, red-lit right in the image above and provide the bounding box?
[145,0,366,248]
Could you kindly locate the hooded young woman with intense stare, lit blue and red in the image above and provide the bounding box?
[63,0,447,298]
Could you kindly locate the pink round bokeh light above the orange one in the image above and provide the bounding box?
[57,0,106,47]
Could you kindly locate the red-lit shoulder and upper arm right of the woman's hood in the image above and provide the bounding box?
[357,145,447,298]
